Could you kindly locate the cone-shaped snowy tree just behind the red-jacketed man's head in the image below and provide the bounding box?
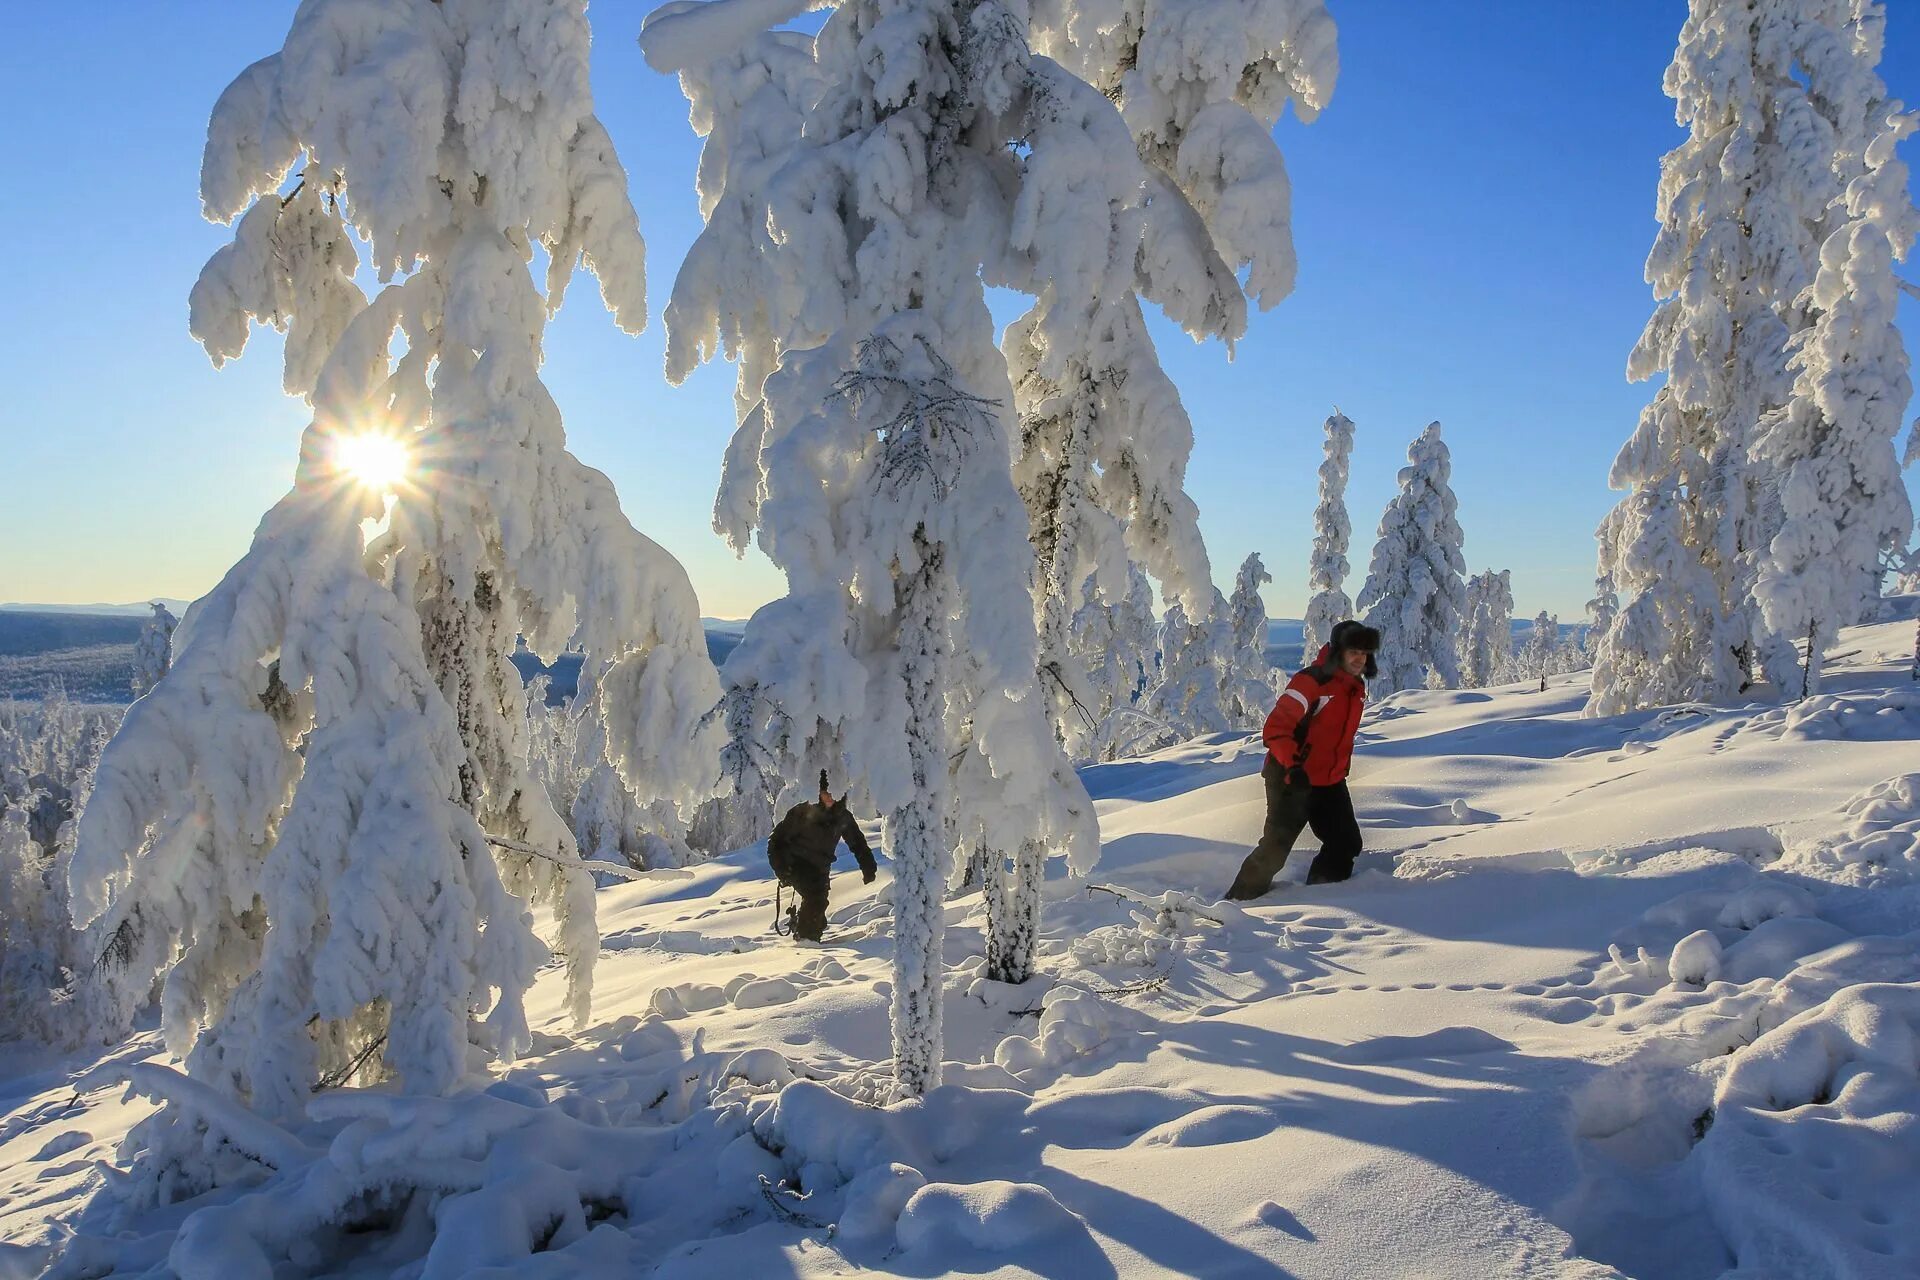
[1357,422,1467,695]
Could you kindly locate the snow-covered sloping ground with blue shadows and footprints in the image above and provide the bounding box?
[0,622,1920,1280]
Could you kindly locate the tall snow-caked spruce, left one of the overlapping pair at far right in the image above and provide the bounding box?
[1592,0,1884,716]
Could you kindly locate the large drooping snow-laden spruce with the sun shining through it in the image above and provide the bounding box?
[71,0,718,1143]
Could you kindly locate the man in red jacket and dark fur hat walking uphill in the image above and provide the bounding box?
[1227,618,1380,900]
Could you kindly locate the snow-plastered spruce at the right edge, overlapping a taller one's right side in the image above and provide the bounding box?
[1755,4,1920,695]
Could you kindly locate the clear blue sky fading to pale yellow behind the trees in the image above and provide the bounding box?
[0,0,1920,622]
